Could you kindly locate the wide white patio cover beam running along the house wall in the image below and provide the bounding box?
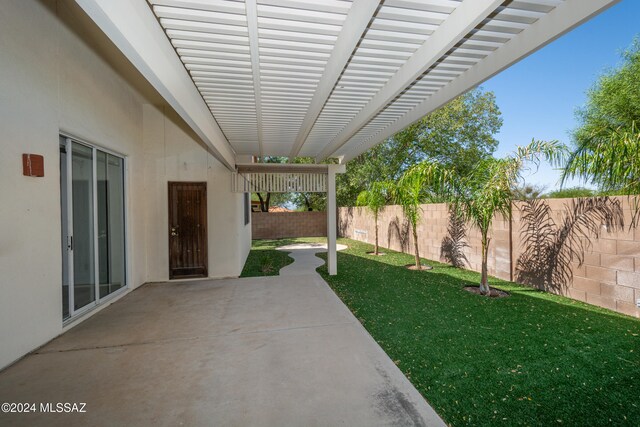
[75,0,235,170]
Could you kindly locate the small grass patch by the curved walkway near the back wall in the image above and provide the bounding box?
[240,237,327,277]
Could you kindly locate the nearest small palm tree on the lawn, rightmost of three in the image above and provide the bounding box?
[411,140,566,295]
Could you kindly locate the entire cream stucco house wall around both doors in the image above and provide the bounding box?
[0,0,251,368]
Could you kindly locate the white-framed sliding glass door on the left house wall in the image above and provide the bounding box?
[60,137,126,319]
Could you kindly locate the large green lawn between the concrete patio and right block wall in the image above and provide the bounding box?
[302,240,640,426]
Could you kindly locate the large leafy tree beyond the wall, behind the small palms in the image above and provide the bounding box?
[337,89,502,206]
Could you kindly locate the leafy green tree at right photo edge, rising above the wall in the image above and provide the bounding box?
[562,39,640,221]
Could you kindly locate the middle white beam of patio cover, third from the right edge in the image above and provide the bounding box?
[289,0,380,160]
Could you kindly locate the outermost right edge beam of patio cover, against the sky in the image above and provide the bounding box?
[343,0,619,162]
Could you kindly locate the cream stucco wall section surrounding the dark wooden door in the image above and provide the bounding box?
[143,104,251,281]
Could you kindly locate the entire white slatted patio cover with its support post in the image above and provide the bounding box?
[76,0,617,272]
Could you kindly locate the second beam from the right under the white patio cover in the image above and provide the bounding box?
[317,0,503,160]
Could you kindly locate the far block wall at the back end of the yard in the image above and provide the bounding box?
[251,212,327,239]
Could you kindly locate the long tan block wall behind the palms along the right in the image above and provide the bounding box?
[338,197,640,317]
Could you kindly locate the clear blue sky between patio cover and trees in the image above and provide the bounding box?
[482,0,640,191]
